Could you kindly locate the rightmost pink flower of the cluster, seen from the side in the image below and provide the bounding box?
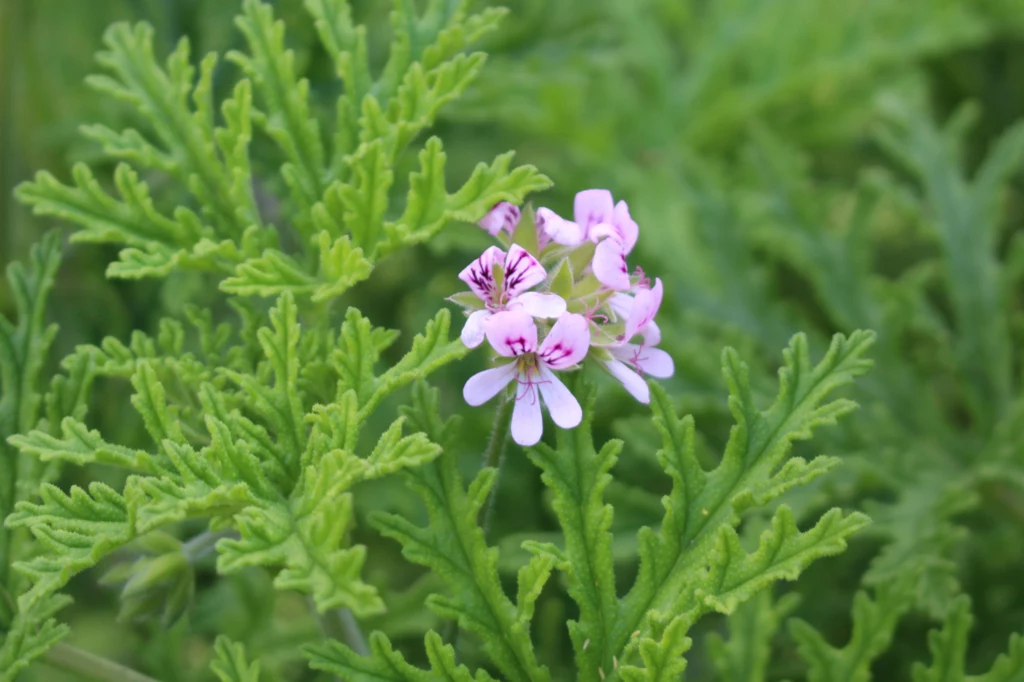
[603,280,675,403]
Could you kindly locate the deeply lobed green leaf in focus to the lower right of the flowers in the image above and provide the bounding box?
[611,332,873,652]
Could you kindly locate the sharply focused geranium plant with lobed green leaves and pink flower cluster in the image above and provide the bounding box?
[0,0,872,682]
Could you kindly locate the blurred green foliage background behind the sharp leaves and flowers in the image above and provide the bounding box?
[6,0,1024,680]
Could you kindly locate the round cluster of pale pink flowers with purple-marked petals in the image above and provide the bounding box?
[451,189,674,445]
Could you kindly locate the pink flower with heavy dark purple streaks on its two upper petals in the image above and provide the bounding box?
[459,244,565,348]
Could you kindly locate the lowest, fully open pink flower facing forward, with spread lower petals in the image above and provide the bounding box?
[462,310,590,445]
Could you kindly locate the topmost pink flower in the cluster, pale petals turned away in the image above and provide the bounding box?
[537,189,640,291]
